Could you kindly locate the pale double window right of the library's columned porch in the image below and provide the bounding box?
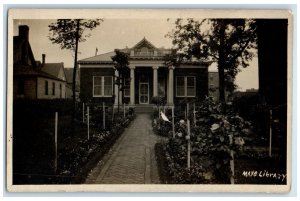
[176,76,196,97]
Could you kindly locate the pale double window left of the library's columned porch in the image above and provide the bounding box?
[93,76,113,97]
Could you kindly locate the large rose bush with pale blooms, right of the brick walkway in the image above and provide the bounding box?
[157,98,252,183]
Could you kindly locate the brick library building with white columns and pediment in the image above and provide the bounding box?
[78,38,209,105]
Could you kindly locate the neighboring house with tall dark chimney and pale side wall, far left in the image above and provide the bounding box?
[13,25,66,99]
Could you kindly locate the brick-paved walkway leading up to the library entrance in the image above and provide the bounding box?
[85,114,159,184]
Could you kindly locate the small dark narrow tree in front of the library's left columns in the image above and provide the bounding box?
[111,49,129,112]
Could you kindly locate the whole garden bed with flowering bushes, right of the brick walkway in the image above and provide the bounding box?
[153,98,286,184]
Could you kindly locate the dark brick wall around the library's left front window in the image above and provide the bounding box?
[80,67,114,104]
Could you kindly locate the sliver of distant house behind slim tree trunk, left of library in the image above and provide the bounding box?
[65,68,80,99]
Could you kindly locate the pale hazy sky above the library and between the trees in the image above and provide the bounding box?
[14,19,258,91]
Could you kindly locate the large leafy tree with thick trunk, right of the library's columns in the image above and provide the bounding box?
[167,18,257,102]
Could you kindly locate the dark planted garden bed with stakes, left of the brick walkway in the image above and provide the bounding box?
[13,100,135,184]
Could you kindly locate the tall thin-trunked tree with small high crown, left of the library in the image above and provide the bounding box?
[48,19,103,104]
